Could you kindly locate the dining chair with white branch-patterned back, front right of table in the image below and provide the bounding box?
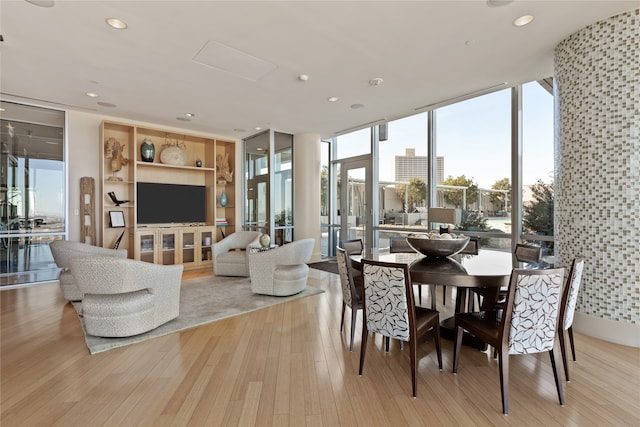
[453,268,564,415]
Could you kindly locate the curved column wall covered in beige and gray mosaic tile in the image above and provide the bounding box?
[554,9,640,324]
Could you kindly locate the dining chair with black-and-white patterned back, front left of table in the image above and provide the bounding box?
[359,259,442,397]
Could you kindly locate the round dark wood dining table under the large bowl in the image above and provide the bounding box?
[350,249,521,348]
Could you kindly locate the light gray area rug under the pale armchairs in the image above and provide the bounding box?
[73,276,324,354]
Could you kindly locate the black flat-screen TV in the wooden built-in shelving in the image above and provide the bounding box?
[136,182,207,225]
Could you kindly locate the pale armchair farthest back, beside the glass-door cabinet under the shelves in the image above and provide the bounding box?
[212,231,260,277]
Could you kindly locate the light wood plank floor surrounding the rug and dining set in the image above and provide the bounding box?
[0,270,640,427]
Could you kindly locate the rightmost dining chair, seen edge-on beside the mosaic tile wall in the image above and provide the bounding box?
[558,258,584,382]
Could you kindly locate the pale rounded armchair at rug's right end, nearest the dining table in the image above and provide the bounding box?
[248,239,315,296]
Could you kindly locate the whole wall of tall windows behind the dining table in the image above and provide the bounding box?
[326,82,553,255]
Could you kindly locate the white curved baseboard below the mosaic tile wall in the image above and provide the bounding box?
[573,311,640,348]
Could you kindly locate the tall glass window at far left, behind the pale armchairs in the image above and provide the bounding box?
[0,102,66,285]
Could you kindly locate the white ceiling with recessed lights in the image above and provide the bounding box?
[0,0,640,139]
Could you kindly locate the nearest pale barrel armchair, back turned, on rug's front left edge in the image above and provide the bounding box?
[71,257,183,337]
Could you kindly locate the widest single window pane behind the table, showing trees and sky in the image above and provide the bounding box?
[435,89,511,250]
